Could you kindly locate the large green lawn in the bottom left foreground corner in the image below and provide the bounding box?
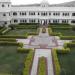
[0,46,27,75]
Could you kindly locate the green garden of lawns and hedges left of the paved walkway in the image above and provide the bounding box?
[0,24,39,75]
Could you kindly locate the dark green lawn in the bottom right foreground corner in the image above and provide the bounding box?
[58,48,75,75]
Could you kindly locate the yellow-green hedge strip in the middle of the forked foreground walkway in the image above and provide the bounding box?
[38,57,47,75]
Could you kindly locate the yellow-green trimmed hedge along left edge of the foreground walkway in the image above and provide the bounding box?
[23,50,34,75]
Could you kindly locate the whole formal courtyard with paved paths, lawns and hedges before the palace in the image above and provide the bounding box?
[0,25,75,75]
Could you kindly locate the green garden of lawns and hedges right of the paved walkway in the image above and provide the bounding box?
[49,24,75,75]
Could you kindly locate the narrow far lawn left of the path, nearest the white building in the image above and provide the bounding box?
[6,29,37,35]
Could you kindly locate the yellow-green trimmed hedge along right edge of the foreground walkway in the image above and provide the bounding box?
[52,49,61,75]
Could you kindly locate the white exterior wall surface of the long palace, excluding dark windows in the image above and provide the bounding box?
[0,2,75,25]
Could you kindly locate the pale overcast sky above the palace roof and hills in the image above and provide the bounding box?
[11,0,74,5]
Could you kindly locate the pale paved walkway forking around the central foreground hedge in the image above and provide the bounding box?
[31,49,54,75]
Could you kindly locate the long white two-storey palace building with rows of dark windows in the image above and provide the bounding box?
[0,0,75,26]
